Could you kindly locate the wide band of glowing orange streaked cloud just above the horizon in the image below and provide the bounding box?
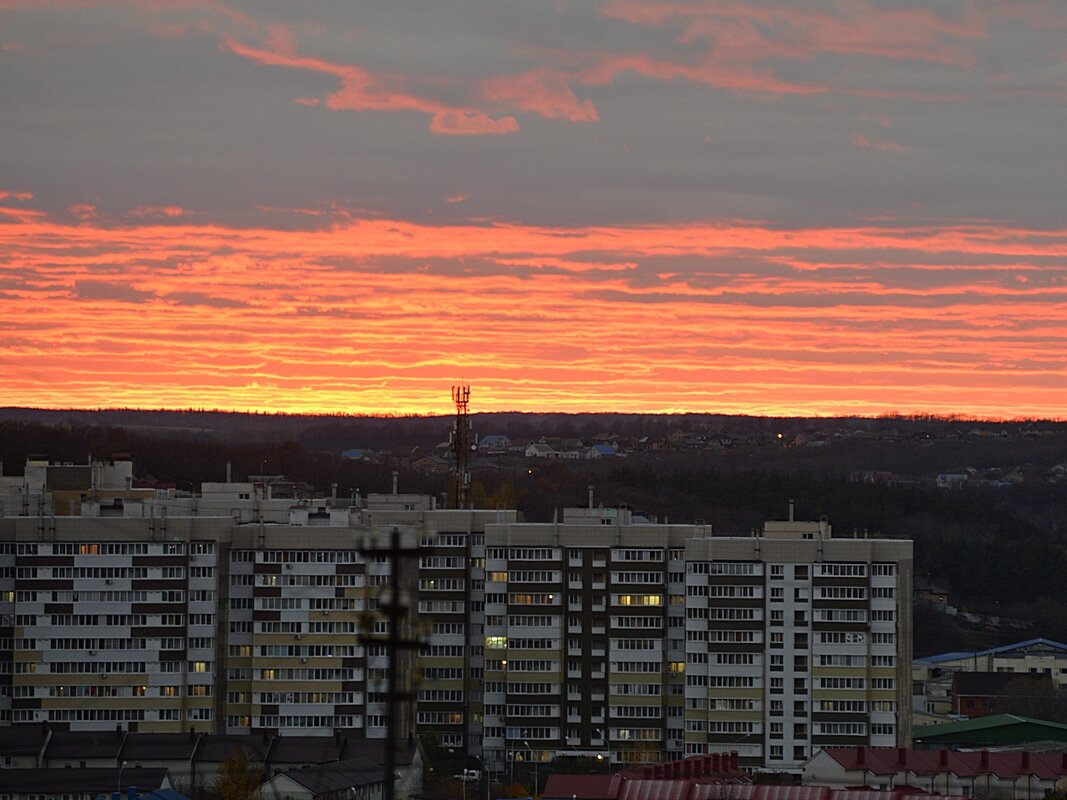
[0,206,1067,416]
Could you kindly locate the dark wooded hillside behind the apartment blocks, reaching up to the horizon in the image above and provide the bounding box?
[6,409,1067,655]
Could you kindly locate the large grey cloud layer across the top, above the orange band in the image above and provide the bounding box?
[0,0,1067,226]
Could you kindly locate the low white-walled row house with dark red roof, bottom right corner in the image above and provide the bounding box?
[801,746,1067,800]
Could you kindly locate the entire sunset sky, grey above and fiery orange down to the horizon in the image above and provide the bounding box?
[0,0,1067,418]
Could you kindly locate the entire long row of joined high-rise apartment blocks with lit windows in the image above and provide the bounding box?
[0,462,912,773]
